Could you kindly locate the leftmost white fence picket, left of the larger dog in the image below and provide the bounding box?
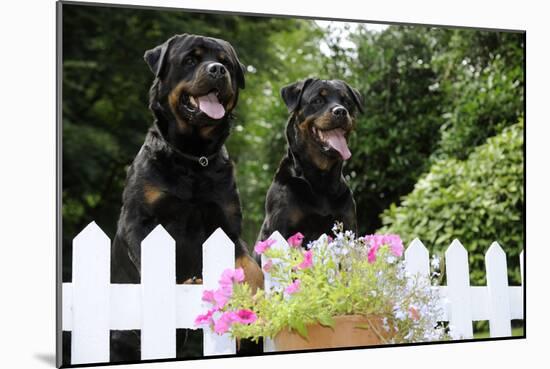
[70,222,111,364]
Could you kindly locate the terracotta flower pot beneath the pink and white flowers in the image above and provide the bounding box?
[274,315,388,351]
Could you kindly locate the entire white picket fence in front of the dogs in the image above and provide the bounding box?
[62,222,524,364]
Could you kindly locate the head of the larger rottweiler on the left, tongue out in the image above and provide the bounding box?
[144,34,244,132]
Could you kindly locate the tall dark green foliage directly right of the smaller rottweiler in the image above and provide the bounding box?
[346,27,448,233]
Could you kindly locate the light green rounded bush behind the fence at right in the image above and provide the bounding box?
[382,121,525,285]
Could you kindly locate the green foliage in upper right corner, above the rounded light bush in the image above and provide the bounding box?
[433,30,525,159]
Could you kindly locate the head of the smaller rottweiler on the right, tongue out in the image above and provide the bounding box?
[281,78,363,170]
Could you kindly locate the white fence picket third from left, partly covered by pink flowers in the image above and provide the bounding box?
[202,228,236,355]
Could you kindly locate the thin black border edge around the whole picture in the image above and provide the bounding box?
[55,0,527,368]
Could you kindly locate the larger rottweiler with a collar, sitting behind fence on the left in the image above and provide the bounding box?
[111,34,263,361]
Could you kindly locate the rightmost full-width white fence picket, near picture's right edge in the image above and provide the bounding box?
[485,242,512,337]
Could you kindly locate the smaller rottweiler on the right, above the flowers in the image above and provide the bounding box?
[258,78,363,245]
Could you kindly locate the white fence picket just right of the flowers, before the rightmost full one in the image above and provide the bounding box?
[445,239,474,338]
